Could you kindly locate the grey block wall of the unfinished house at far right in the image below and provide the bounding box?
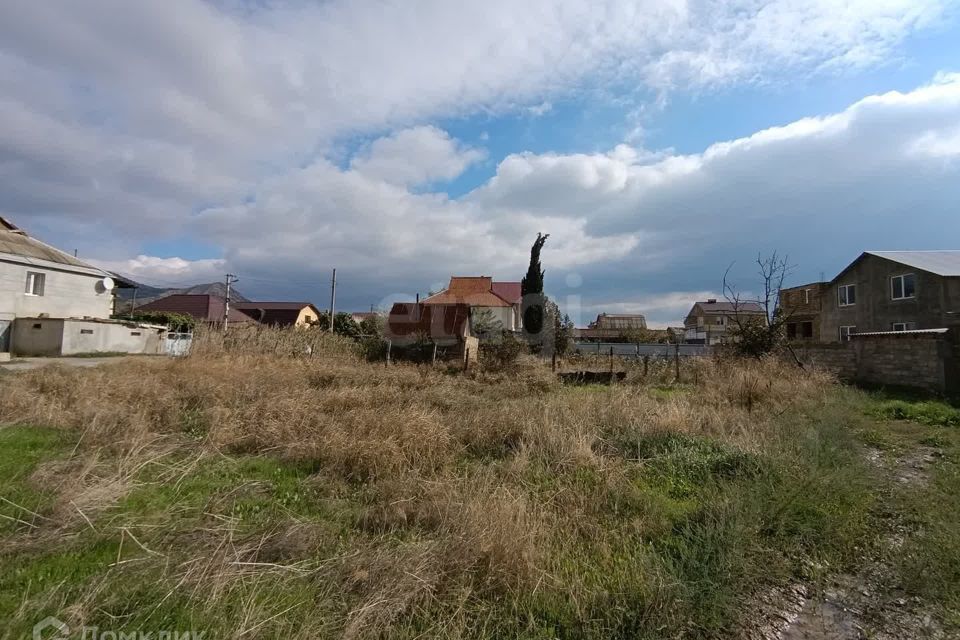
[821,254,960,342]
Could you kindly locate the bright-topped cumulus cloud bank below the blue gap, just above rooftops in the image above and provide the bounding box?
[107,76,960,325]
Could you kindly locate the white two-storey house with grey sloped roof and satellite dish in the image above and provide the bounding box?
[0,218,113,353]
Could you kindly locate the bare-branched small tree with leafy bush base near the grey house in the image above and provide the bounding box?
[723,251,799,364]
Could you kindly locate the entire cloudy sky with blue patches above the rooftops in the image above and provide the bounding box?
[0,0,960,327]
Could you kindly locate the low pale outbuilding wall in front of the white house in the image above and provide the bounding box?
[12,318,166,356]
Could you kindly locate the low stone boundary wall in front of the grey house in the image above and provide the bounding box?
[796,329,960,395]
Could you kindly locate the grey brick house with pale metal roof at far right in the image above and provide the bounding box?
[821,251,960,342]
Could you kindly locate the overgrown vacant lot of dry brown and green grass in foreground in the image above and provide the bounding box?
[0,338,960,638]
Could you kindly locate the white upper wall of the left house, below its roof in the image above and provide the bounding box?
[0,261,113,320]
